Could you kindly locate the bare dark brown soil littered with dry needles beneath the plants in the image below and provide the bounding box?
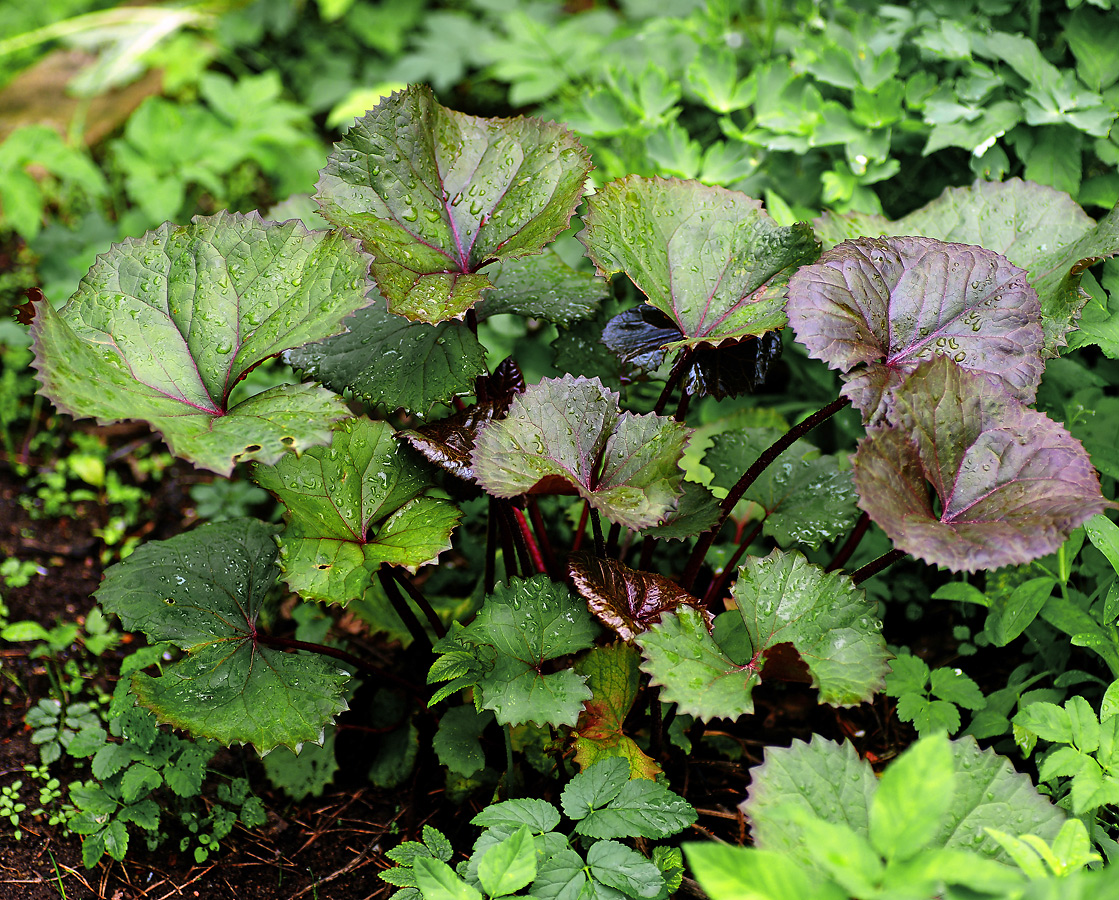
[0,426,911,900]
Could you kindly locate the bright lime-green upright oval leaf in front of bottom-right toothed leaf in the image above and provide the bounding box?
[869,735,956,861]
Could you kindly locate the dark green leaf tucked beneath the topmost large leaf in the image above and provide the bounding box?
[285,299,486,415]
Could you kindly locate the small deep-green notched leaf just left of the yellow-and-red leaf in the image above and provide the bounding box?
[447,575,598,725]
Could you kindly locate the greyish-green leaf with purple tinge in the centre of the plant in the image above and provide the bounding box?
[472,375,688,529]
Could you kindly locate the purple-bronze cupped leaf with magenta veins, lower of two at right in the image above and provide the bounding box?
[855,357,1111,572]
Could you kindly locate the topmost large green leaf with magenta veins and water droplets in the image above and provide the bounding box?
[316,85,591,324]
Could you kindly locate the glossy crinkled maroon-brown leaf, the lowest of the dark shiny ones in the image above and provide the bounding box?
[567,553,702,640]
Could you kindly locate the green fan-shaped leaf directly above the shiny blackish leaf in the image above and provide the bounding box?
[579,176,818,346]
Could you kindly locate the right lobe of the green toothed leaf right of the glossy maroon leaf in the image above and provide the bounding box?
[732,550,888,706]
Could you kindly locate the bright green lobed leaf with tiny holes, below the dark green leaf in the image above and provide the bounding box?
[253,418,461,606]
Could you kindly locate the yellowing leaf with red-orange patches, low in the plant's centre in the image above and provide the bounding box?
[572,643,660,779]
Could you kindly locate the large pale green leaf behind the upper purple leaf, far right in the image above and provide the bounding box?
[812,178,1119,357]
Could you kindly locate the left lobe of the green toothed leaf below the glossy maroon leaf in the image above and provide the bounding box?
[634,607,759,722]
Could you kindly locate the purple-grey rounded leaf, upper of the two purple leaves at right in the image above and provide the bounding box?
[787,237,1044,421]
